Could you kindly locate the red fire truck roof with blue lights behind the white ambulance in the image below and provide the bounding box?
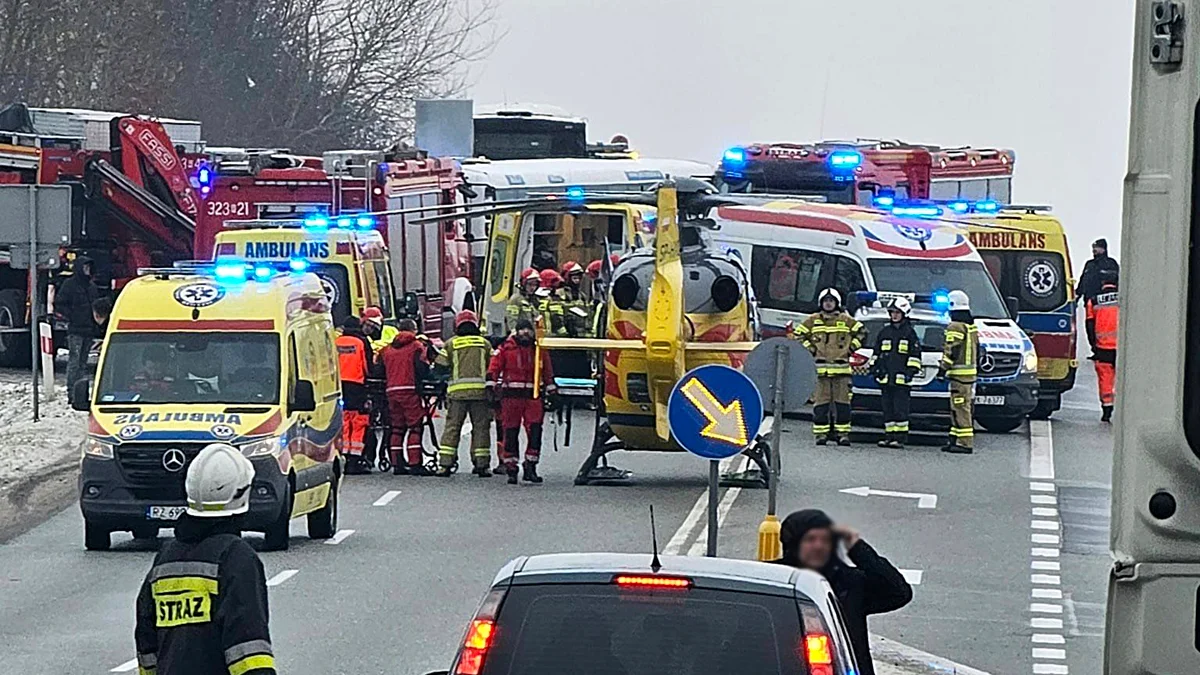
[716,139,1016,205]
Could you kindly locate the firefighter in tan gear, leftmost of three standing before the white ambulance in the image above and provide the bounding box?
[792,288,866,446]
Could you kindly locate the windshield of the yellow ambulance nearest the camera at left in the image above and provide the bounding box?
[96,333,280,405]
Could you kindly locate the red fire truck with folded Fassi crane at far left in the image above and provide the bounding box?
[0,104,199,366]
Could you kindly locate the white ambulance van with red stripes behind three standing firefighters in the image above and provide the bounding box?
[712,199,1038,431]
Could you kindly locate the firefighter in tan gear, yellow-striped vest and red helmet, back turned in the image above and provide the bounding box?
[434,310,492,478]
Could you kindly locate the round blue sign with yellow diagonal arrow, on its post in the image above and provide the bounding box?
[667,364,763,557]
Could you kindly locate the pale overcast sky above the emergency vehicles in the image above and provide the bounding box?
[470,0,1133,267]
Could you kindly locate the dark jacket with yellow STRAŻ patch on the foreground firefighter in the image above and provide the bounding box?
[133,533,275,675]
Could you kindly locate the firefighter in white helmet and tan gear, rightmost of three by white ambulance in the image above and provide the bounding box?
[937,291,979,454]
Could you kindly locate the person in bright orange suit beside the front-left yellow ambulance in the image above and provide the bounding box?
[335,316,374,474]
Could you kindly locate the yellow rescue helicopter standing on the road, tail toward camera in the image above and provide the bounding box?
[414,179,770,486]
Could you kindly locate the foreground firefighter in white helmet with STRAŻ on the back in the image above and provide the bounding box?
[133,443,275,675]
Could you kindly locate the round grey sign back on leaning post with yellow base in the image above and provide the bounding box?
[743,338,817,561]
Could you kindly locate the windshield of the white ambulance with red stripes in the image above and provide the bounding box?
[869,258,1009,318]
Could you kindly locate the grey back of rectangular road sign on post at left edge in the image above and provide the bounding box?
[0,185,71,422]
